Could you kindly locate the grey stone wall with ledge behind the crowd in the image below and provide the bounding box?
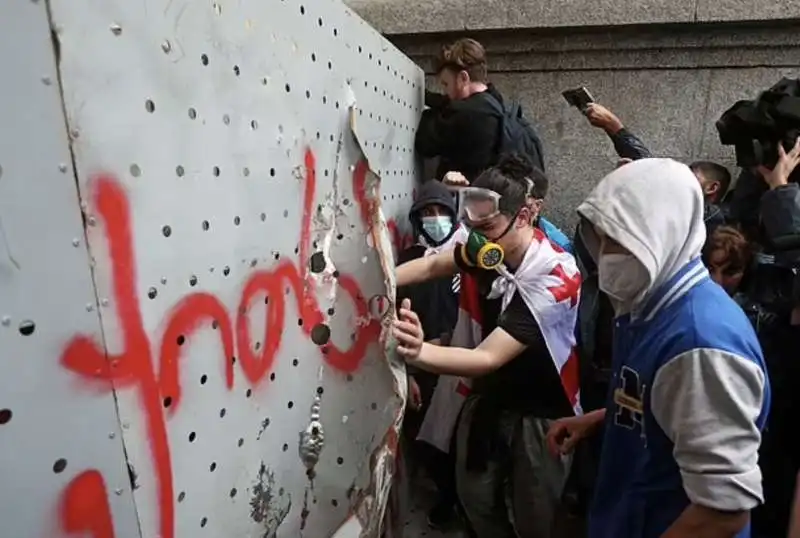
[349,0,800,227]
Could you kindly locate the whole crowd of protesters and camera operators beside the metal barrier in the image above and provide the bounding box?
[394,39,800,538]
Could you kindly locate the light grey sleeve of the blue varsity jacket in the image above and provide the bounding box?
[650,349,766,511]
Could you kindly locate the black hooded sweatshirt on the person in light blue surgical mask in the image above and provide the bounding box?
[397,180,460,340]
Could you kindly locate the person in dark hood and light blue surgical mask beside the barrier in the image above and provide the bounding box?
[397,180,461,528]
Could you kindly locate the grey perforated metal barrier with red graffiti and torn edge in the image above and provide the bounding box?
[0,0,423,538]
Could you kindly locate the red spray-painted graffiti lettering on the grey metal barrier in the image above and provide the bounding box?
[55,150,380,538]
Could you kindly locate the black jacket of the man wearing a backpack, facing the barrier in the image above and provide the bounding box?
[416,84,503,182]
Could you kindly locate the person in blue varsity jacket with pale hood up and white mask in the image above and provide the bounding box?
[548,159,770,538]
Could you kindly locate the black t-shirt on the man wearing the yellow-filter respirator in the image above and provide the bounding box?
[473,271,573,418]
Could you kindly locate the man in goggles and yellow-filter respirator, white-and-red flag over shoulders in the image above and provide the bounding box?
[395,156,580,538]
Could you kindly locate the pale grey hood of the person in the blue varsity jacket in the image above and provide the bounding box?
[578,159,706,304]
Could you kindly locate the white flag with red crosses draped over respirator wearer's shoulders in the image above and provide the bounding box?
[417,228,582,452]
